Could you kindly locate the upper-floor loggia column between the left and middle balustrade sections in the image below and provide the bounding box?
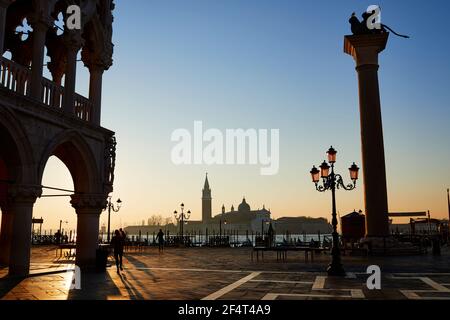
[31,19,50,101]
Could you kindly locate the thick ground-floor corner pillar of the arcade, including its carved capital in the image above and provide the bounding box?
[71,194,107,271]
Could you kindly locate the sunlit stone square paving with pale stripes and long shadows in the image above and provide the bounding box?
[0,247,450,300]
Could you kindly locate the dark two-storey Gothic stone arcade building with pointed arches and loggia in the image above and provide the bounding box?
[0,0,116,275]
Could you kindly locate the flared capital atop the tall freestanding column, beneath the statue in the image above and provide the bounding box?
[344,32,389,67]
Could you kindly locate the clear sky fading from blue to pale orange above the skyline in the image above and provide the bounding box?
[29,0,450,230]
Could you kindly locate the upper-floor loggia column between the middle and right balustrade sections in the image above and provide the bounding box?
[63,31,83,114]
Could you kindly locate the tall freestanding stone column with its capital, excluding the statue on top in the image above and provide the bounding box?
[344,33,389,238]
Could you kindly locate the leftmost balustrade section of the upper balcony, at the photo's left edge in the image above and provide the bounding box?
[0,58,31,95]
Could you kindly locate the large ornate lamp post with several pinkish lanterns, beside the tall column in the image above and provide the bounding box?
[310,147,359,276]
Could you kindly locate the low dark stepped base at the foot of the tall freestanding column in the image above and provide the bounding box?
[360,236,424,256]
